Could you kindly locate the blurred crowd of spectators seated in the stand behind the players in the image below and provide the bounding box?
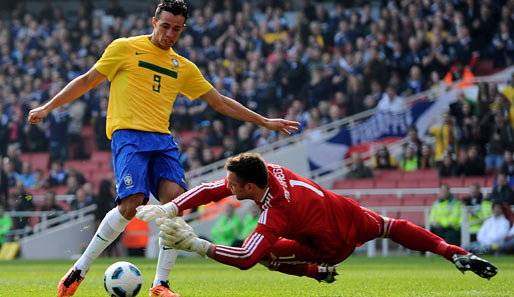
[0,0,514,253]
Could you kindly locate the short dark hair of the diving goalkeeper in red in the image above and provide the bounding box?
[225,153,268,189]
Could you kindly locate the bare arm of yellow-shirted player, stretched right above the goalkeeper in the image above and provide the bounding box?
[201,88,300,135]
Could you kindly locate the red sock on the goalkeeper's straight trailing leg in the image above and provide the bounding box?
[384,219,468,262]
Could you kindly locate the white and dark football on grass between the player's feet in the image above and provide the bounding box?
[104,261,143,297]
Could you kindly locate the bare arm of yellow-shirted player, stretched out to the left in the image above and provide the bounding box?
[28,68,106,124]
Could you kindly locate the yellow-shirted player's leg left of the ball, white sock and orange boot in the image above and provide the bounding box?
[57,193,144,297]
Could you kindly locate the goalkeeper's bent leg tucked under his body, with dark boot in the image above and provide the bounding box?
[260,238,337,283]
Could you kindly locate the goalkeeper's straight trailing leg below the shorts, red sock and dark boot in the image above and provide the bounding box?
[381,217,497,278]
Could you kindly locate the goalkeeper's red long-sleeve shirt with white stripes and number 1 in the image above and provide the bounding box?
[173,163,382,269]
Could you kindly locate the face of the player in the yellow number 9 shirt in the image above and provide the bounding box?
[152,11,186,50]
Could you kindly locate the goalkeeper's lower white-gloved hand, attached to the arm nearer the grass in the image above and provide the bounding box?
[159,218,210,255]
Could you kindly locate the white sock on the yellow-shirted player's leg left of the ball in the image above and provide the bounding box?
[75,207,130,277]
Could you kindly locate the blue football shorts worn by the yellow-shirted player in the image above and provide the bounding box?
[111,130,187,204]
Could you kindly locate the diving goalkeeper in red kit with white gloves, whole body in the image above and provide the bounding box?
[136,153,497,282]
